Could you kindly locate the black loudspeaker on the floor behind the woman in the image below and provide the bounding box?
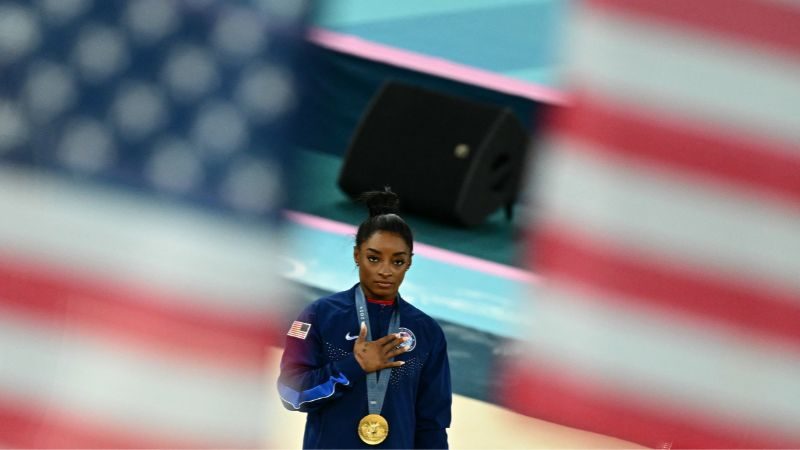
[339,82,528,226]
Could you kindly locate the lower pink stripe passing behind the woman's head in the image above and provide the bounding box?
[284,210,539,283]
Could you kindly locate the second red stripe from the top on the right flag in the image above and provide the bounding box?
[551,93,800,205]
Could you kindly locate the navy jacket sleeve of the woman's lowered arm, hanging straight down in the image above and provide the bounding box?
[414,329,453,448]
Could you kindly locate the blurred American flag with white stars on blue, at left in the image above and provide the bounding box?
[0,0,308,448]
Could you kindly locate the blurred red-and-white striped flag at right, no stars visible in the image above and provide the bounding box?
[504,0,800,448]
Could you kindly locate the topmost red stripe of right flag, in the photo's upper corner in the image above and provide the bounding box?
[588,0,800,57]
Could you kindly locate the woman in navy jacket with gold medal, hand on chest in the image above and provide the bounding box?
[278,188,452,448]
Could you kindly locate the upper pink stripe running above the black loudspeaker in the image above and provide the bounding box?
[307,28,568,105]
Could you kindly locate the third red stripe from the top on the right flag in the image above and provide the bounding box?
[532,222,800,347]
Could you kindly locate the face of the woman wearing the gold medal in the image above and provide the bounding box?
[353,231,411,300]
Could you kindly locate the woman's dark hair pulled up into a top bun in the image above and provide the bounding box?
[356,187,414,253]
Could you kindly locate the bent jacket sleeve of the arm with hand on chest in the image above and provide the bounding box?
[278,304,364,412]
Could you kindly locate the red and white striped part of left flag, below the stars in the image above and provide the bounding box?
[0,168,285,448]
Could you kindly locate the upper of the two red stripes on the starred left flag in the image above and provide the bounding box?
[0,251,282,371]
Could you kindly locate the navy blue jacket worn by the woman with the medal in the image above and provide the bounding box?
[278,284,452,448]
